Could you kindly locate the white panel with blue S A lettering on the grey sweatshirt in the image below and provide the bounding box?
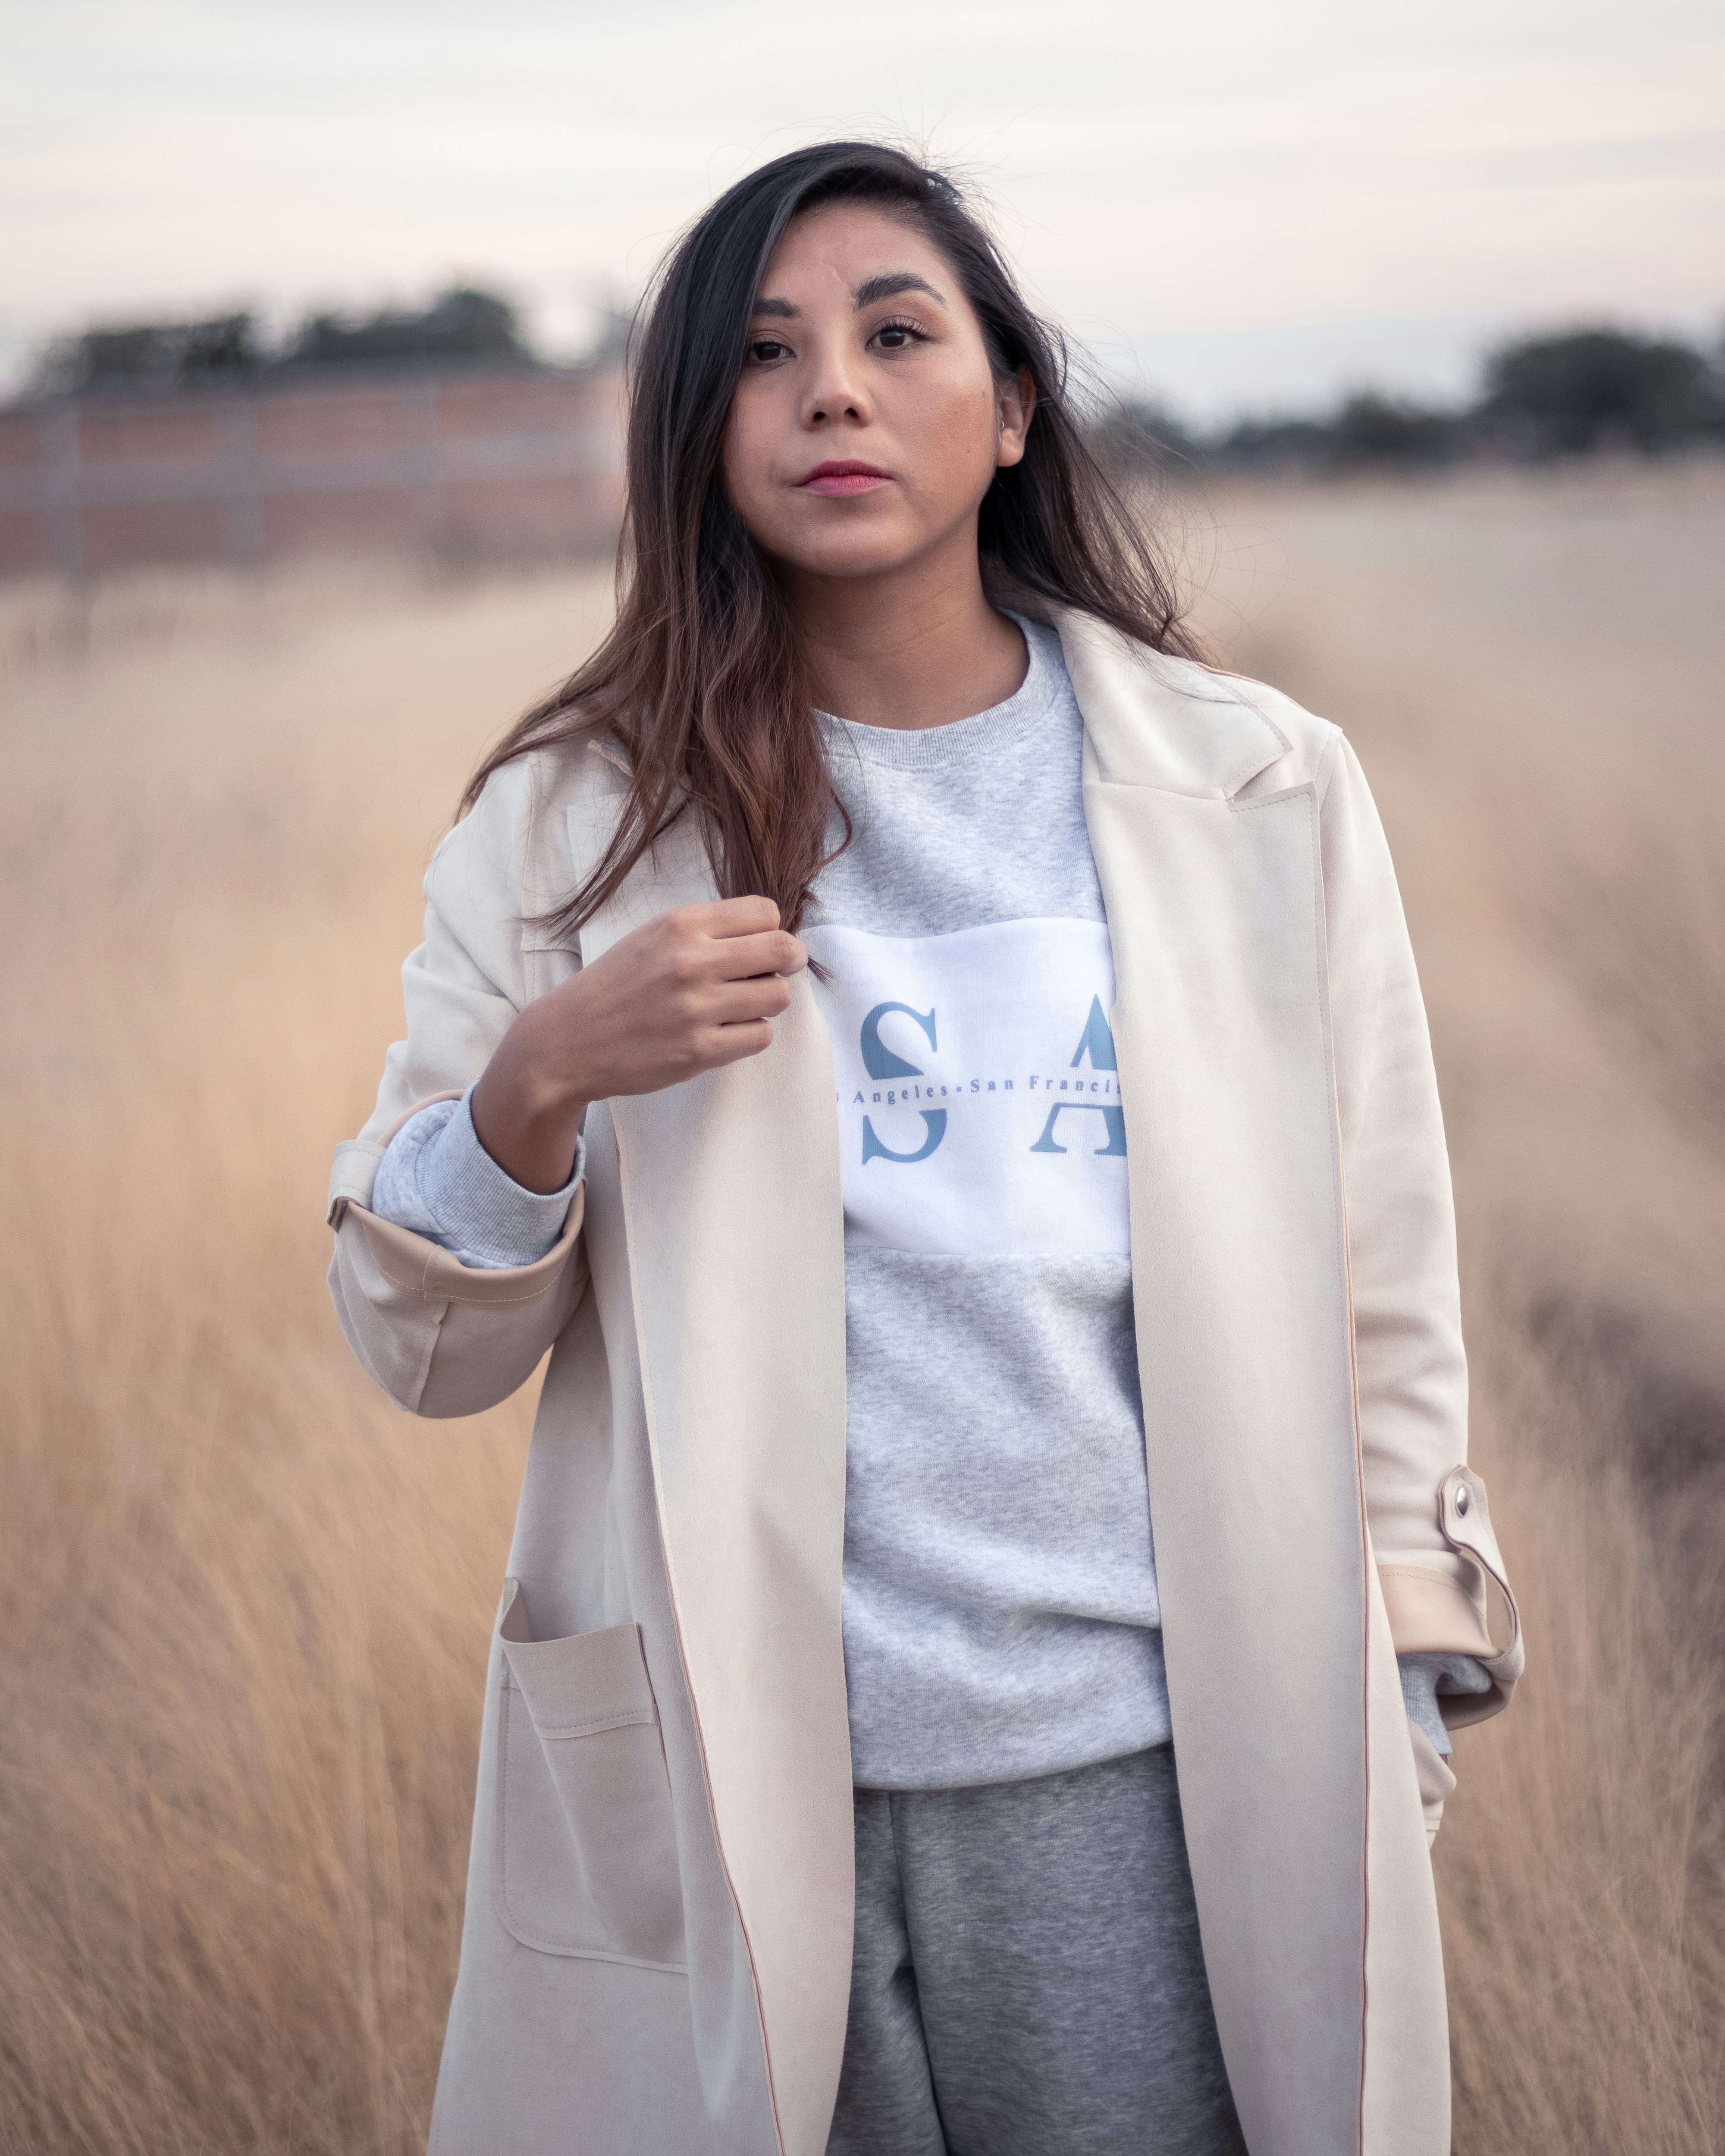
[802,921,1130,1257]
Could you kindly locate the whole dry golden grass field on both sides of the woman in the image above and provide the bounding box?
[0,466,1725,2156]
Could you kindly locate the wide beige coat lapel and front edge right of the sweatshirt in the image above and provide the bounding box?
[1061,619,1367,2156]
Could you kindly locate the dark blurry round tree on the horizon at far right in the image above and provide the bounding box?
[1473,330,1714,455]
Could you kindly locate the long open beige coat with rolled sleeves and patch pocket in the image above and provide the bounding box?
[330,617,1520,2156]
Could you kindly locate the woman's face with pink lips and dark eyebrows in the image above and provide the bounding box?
[724,203,1033,578]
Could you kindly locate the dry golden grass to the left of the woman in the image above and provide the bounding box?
[0,567,612,2156]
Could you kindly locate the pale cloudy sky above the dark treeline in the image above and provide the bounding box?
[0,0,1725,418]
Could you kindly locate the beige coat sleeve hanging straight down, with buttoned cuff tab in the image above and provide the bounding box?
[1322,740,1522,1727]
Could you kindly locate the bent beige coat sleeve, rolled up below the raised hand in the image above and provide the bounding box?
[330,759,586,1416]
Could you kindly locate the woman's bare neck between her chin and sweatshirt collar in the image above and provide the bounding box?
[787,530,1029,733]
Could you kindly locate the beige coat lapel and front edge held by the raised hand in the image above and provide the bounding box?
[569,800,854,2156]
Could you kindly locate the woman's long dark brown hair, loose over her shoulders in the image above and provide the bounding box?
[461,142,1199,934]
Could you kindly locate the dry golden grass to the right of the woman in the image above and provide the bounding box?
[1201,464,1725,2156]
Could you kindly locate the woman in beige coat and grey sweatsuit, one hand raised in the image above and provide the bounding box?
[332,144,1520,2156]
